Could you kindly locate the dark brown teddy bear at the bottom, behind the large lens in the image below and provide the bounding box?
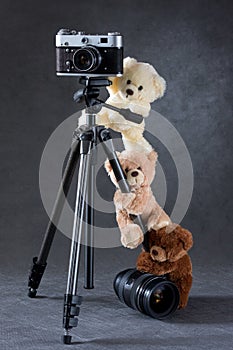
[137,224,193,308]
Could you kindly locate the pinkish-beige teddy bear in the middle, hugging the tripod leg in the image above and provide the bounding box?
[105,150,170,249]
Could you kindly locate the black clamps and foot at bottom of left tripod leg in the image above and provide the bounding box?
[28,257,47,298]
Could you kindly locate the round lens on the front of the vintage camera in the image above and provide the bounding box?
[73,46,101,72]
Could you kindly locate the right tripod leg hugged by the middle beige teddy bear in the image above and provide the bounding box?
[99,126,149,251]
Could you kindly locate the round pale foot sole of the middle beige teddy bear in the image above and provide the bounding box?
[121,224,144,249]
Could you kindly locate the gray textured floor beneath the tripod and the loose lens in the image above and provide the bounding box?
[0,258,233,350]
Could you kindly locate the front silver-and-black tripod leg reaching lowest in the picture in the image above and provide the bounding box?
[63,131,93,344]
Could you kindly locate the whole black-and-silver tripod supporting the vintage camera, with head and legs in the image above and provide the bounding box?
[28,77,146,344]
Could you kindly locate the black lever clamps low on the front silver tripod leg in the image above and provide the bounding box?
[63,294,82,330]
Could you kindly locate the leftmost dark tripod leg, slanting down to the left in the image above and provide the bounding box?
[28,140,80,298]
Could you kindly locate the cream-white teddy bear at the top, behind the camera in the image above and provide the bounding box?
[97,57,166,153]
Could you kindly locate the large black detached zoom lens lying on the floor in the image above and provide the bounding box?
[113,269,179,319]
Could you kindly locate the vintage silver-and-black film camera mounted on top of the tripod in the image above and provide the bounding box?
[56,29,123,77]
